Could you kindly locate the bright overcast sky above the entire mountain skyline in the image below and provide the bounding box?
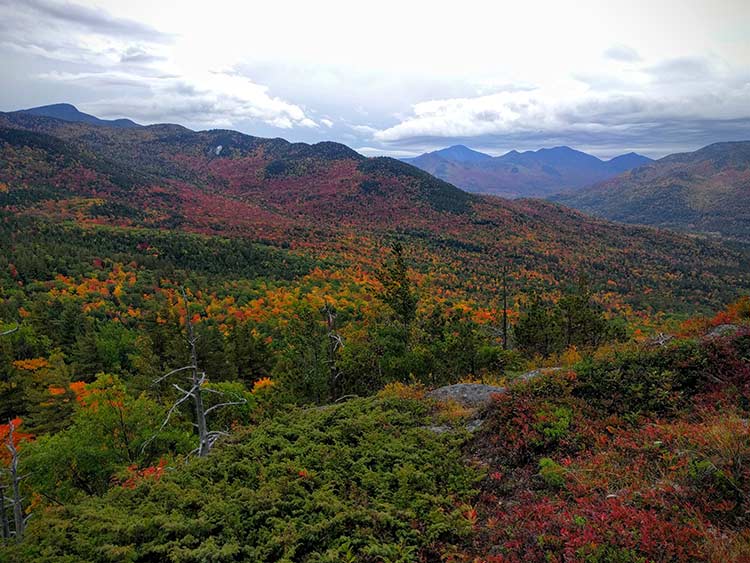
[0,0,750,158]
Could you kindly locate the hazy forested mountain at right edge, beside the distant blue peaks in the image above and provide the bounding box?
[554,141,750,241]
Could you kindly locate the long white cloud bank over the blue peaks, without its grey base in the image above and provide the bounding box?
[374,69,750,143]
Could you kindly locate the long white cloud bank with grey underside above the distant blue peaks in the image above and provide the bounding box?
[373,76,750,156]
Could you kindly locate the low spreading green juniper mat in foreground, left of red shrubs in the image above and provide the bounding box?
[10,399,478,563]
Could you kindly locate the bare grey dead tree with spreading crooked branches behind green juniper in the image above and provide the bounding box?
[149,289,247,457]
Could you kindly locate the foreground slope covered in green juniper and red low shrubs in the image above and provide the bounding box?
[0,318,750,563]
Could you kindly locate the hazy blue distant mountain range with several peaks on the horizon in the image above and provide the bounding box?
[404,145,652,198]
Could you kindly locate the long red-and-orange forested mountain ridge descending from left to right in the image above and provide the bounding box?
[0,108,748,310]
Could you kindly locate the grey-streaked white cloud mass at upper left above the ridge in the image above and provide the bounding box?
[0,0,318,129]
